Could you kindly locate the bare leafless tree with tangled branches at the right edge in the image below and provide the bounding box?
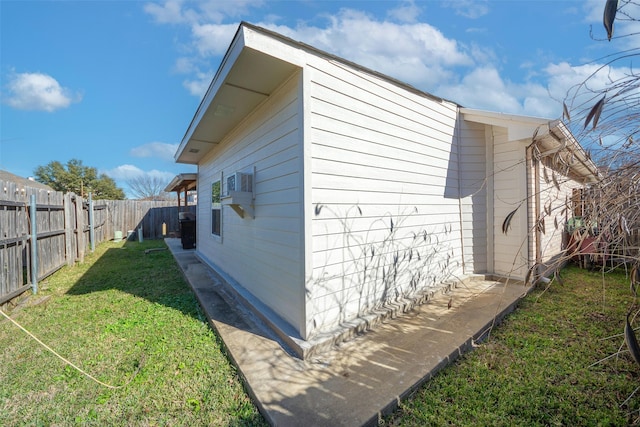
[552,0,640,408]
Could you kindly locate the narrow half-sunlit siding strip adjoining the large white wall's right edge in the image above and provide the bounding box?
[457,120,492,274]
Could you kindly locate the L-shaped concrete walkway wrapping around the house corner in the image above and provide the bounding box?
[165,239,529,426]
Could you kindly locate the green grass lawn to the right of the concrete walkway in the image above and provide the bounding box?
[385,267,640,426]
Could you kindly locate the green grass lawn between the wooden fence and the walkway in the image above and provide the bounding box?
[0,241,264,426]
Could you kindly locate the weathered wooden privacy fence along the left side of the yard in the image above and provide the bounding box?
[0,180,195,305]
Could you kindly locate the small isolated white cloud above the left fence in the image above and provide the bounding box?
[5,73,82,112]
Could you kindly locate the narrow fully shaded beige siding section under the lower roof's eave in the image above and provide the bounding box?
[492,126,528,279]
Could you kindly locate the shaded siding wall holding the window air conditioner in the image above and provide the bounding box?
[197,73,305,330]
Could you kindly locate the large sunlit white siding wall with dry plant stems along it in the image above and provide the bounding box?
[305,57,462,336]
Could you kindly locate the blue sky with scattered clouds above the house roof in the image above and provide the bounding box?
[0,0,633,197]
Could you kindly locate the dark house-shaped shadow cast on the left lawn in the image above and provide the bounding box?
[67,240,202,319]
